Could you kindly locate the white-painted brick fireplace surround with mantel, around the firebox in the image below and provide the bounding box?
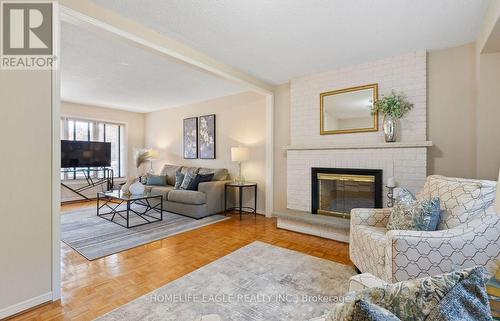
[280,51,431,240]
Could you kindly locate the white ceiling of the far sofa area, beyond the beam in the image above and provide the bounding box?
[61,22,248,112]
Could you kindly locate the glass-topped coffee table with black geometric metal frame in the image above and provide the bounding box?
[97,190,163,228]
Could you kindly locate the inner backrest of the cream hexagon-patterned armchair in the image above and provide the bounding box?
[418,175,496,230]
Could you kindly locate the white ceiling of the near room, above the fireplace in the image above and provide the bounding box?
[93,0,490,84]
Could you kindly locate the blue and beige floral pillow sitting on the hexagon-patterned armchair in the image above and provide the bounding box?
[387,188,441,231]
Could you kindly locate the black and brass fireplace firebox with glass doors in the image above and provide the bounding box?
[311,167,382,218]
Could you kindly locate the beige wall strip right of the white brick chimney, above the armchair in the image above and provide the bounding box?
[427,43,477,178]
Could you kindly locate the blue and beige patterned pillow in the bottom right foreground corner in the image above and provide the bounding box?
[326,267,491,321]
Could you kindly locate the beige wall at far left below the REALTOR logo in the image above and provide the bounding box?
[0,70,53,318]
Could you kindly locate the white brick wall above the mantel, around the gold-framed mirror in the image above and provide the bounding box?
[290,51,427,145]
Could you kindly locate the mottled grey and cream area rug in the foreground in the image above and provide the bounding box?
[97,242,356,321]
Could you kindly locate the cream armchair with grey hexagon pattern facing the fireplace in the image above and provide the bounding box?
[349,175,500,283]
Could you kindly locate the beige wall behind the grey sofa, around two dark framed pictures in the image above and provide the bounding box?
[145,92,266,213]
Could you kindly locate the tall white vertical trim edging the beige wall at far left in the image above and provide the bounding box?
[51,2,61,304]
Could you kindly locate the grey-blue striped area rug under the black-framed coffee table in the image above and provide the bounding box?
[61,207,229,260]
